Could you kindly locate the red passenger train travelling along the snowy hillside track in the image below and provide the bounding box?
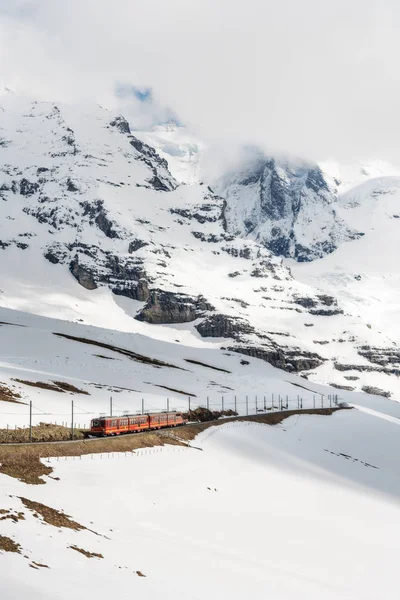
[89,411,188,437]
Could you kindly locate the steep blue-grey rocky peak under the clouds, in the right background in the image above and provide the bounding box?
[217,154,362,261]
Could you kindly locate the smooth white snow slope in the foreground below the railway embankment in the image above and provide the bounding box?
[0,410,400,600]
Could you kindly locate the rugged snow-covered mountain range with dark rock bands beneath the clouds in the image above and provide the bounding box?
[0,94,400,404]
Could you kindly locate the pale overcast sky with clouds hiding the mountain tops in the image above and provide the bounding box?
[0,0,400,164]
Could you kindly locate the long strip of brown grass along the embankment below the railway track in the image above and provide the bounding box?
[0,408,343,484]
